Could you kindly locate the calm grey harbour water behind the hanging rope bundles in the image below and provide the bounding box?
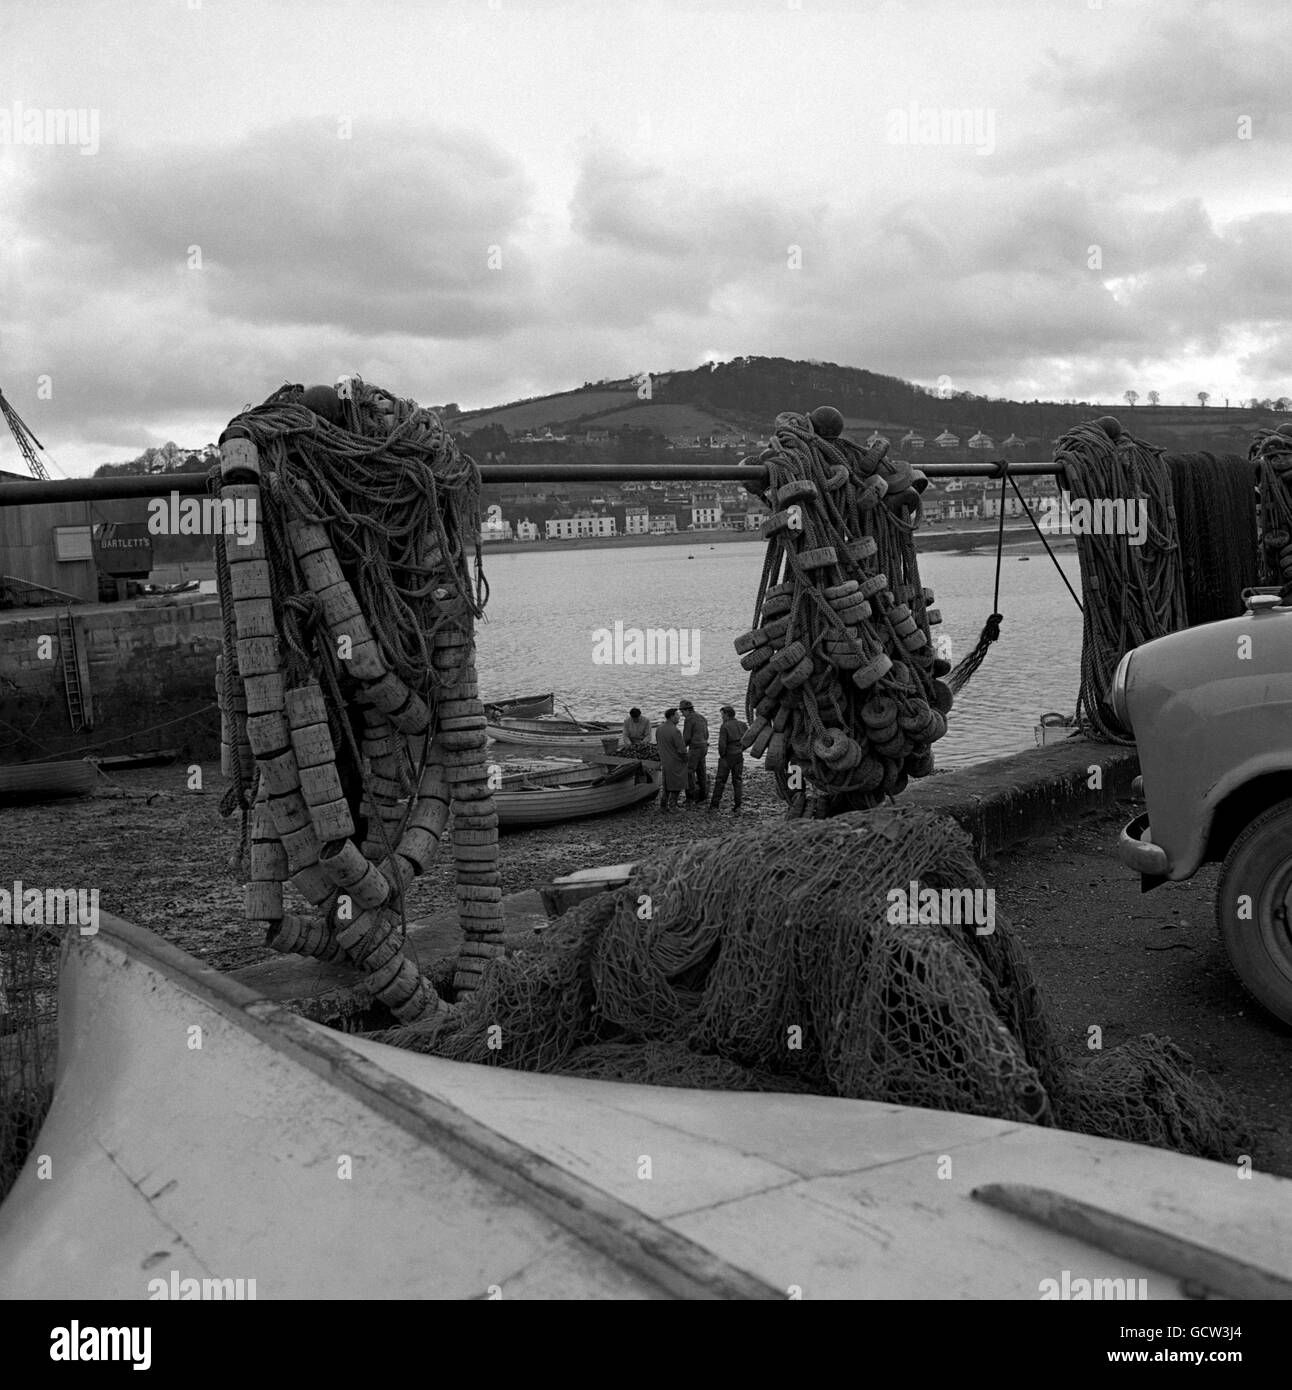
[477,539,1081,767]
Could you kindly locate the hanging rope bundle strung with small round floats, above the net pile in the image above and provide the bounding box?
[736,407,951,817]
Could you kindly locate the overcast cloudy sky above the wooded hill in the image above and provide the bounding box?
[0,0,1292,474]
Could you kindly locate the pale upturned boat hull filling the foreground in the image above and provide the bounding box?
[0,913,1292,1301]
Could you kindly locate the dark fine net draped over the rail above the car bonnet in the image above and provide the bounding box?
[1163,441,1251,627]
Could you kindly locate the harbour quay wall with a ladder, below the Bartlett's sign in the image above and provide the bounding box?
[0,595,220,762]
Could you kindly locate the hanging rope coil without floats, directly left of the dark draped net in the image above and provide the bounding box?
[1054,417,1188,744]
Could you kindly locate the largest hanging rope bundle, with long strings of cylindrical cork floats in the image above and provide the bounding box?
[213,377,502,1019]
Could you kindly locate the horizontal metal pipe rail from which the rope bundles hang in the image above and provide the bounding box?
[0,459,1057,507]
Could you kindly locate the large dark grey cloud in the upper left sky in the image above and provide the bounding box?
[24,120,533,338]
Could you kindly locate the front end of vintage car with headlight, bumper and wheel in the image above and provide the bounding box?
[1110,589,1292,1024]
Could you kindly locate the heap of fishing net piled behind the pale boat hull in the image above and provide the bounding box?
[378,808,1245,1158]
